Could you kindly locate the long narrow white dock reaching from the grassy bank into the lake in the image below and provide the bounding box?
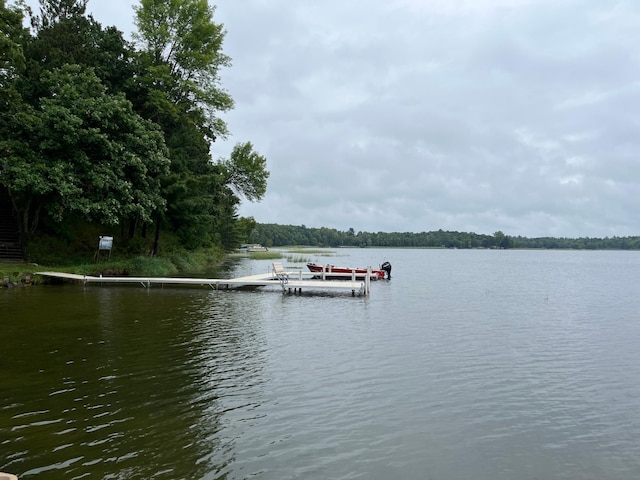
[35,271,370,296]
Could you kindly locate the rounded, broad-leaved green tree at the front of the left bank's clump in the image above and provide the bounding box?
[1,65,169,234]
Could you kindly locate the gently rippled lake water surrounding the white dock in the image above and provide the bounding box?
[0,249,640,480]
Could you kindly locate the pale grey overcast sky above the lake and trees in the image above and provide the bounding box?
[22,0,640,237]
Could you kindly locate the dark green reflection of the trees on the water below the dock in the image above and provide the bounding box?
[0,287,264,478]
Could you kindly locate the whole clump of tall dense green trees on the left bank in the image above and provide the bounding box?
[0,0,269,253]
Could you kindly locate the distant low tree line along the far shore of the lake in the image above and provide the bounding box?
[249,223,640,250]
